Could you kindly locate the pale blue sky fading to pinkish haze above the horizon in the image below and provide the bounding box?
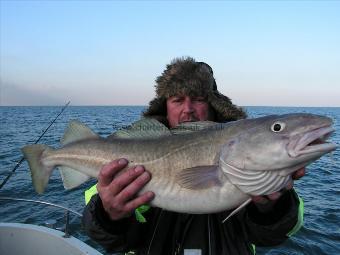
[0,0,340,106]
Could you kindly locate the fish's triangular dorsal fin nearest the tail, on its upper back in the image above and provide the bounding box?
[60,120,99,145]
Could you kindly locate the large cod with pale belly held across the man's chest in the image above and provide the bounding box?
[22,114,336,214]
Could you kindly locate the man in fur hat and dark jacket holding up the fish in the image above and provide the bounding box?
[83,58,304,255]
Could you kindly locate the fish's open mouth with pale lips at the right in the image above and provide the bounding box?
[288,126,336,158]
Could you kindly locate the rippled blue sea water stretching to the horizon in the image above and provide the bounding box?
[0,106,340,255]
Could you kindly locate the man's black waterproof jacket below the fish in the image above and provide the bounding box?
[83,190,299,255]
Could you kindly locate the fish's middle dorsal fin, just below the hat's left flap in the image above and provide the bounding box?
[109,118,171,139]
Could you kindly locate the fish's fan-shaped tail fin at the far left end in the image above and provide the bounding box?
[21,144,54,194]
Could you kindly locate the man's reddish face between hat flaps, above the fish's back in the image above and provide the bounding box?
[166,96,212,128]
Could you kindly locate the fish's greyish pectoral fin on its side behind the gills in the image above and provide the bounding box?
[176,165,222,190]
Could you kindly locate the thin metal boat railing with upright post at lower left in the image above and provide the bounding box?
[0,196,82,238]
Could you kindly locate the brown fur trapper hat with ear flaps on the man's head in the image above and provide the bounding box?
[143,57,246,123]
